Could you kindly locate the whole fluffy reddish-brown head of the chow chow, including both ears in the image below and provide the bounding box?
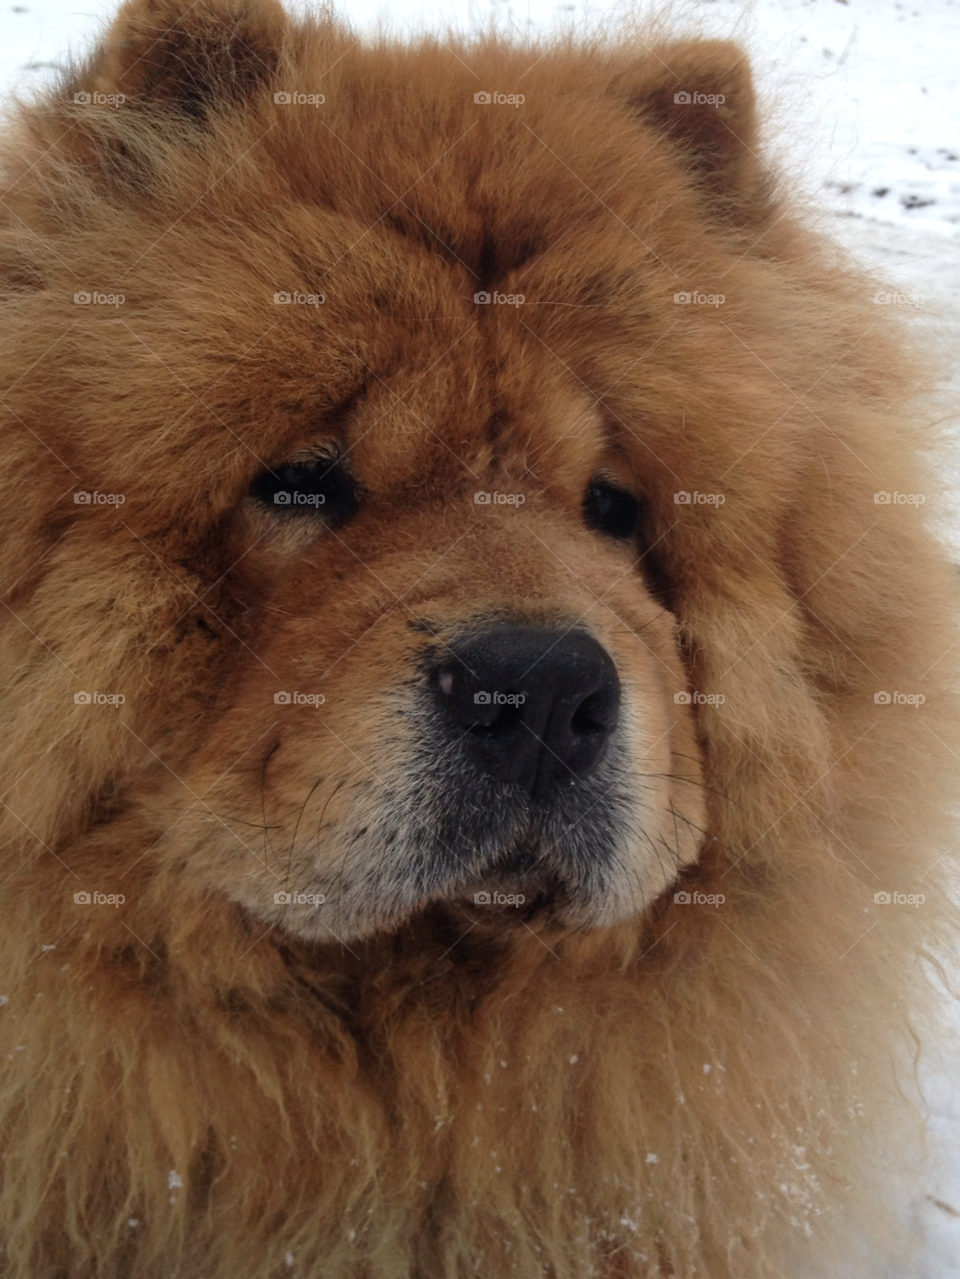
[1,4,915,939]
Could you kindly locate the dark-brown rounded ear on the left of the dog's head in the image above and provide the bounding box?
[78,0,286,120]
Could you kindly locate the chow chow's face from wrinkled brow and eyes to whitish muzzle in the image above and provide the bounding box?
[188,345,703,940]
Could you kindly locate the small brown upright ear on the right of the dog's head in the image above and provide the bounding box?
[615,40,766,221]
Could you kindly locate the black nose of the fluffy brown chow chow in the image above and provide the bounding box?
[431,624,620,799]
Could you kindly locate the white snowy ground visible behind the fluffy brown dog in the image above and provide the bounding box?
[0,0,960,1279]
